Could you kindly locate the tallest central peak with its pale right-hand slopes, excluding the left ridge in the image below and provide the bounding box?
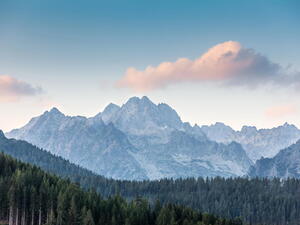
[98,96,252,179]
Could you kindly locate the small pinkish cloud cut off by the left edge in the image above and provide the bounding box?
[0,75,42,102]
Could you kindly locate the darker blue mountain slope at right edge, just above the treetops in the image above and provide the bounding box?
[249,140,300,178]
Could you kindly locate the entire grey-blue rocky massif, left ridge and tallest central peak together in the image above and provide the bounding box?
[6,97,252,180]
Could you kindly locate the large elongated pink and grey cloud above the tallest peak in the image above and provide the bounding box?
[117,41,290,92]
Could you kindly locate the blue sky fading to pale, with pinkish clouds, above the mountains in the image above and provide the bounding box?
[0,0,300,131]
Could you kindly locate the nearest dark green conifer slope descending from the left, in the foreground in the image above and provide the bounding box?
[0,153,242,225]
